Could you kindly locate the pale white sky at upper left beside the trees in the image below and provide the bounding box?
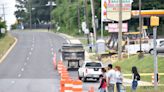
[0,0,16,30]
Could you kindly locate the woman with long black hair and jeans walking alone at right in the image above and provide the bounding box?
[132,66,140,91]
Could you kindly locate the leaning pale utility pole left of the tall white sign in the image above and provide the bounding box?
[91,0,98,42]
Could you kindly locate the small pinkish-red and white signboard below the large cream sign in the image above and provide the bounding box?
[108,23,128,33]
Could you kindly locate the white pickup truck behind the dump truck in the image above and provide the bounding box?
[78,61,103,82]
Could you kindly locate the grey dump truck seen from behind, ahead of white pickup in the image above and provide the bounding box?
[59,43,85,68]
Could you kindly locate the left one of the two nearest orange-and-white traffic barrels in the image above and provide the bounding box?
[64,78,73,92]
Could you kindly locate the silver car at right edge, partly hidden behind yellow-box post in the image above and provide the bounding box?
[144,42,164,55]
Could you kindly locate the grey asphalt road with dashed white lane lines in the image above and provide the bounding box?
[0,31,99,92]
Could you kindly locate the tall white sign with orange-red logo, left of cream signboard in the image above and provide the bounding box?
[101,0,111,22]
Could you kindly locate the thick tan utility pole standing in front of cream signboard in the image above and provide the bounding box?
[118,0,122,60]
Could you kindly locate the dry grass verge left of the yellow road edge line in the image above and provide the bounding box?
[0,34,15,57]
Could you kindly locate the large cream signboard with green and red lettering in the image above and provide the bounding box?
[107,0,133,21]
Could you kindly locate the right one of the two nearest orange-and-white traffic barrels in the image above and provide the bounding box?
[73,79,83,92]
